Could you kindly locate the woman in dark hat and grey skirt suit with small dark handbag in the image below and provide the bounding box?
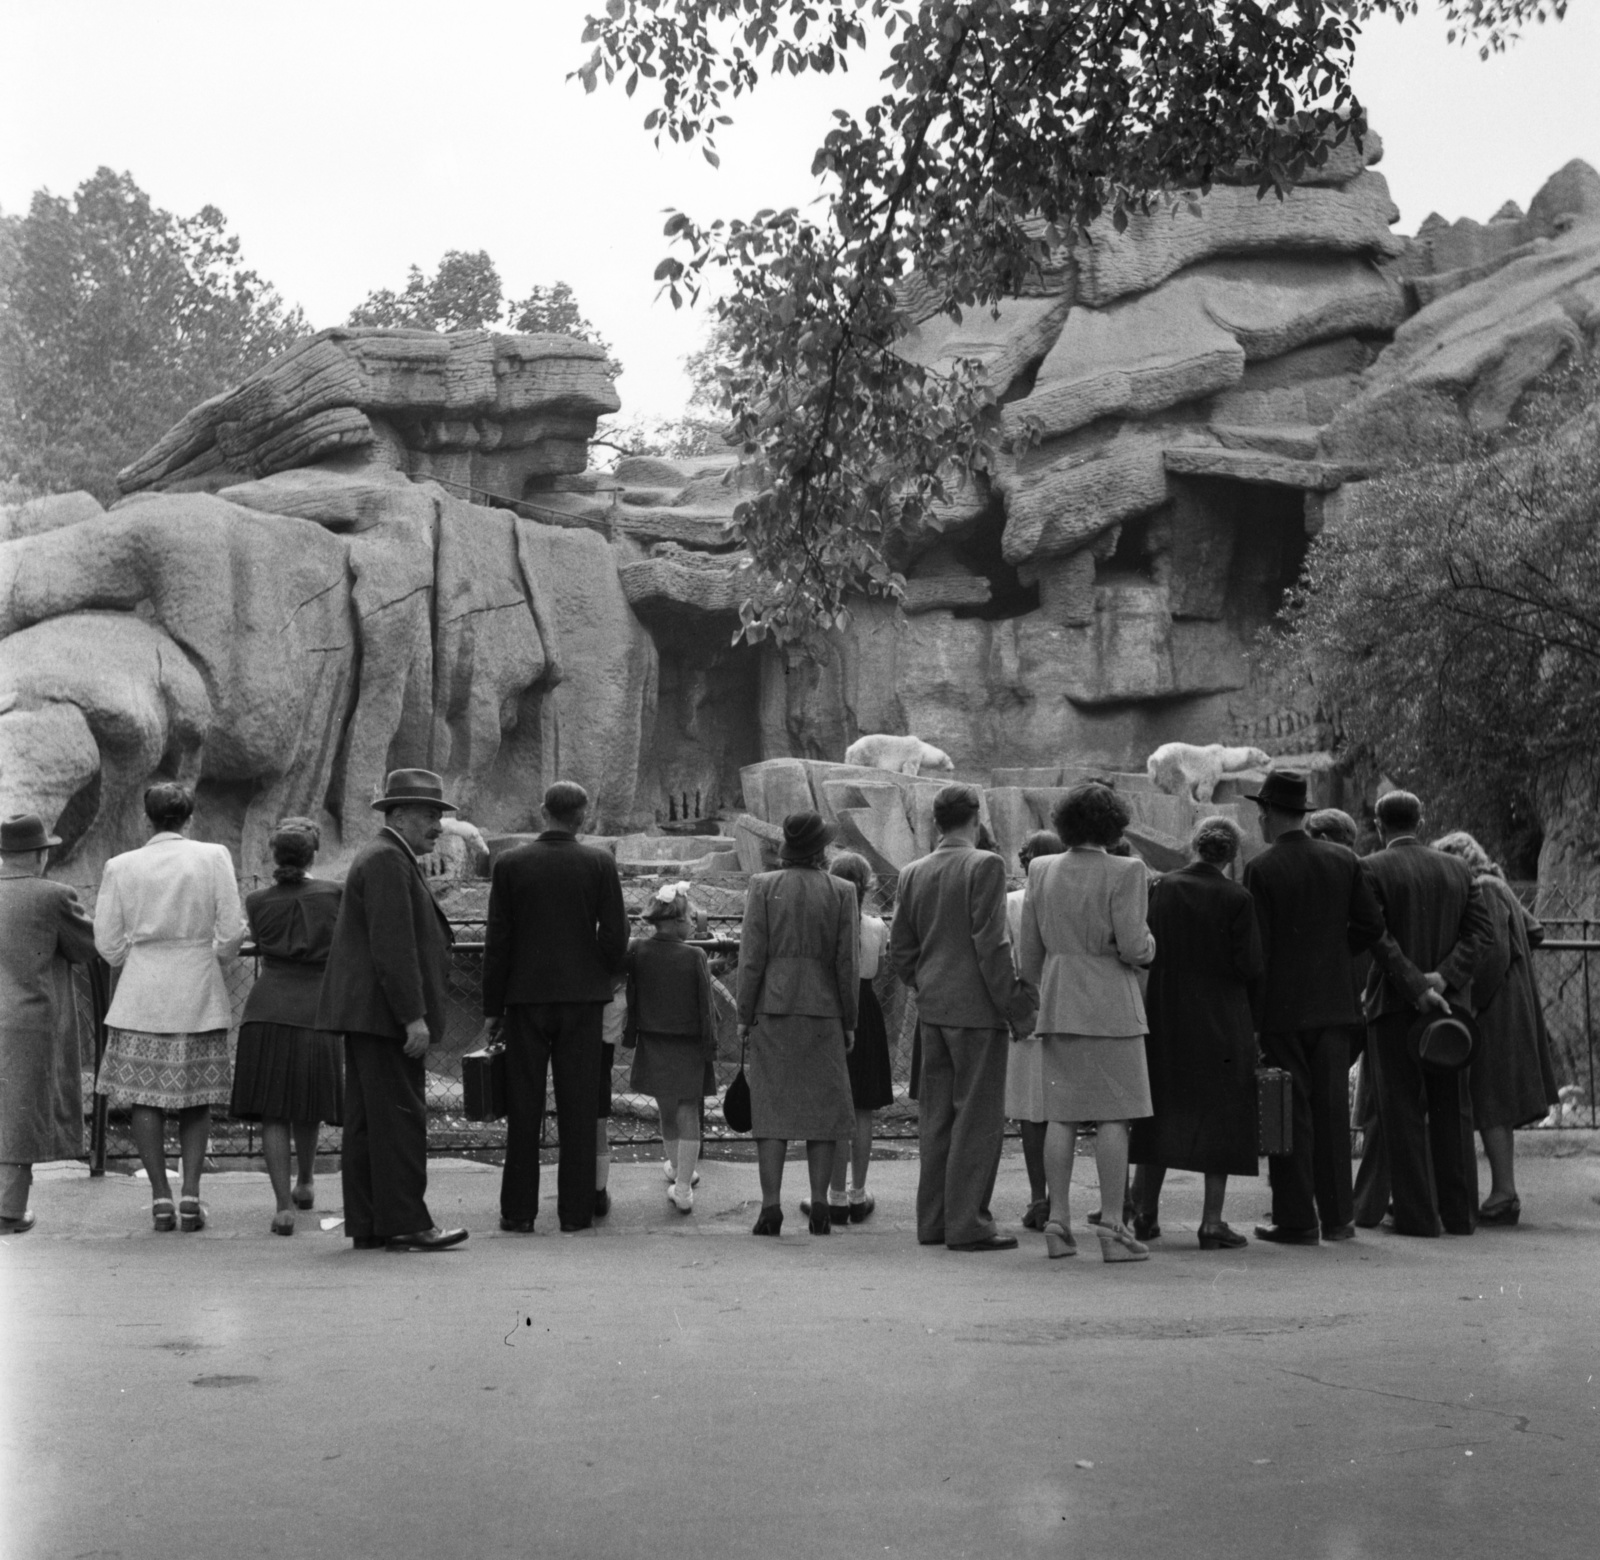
[739,813,859,1235]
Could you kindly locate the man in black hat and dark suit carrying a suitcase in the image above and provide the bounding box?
[1245,770,1408,1246]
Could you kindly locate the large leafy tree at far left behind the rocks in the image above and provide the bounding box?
[0,168,307,501]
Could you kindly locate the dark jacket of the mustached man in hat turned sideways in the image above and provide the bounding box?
[317,829,454,1045]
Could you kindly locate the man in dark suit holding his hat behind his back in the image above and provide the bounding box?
[1366,790,1494,1235]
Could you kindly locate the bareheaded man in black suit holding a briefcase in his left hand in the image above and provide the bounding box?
[483,781,627,1234]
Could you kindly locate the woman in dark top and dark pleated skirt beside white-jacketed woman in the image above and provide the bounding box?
[229,818,344,1235]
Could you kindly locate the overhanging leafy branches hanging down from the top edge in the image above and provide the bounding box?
[576,0,1560,638]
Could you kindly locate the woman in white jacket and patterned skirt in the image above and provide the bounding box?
[94,781,245,1230]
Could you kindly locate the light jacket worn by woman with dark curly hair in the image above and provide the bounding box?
[1022,846,1155,1037]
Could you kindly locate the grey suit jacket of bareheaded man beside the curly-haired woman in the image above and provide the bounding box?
[890,838,1034,1029]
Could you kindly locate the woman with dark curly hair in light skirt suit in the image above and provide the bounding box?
[1022,784,1155,1262]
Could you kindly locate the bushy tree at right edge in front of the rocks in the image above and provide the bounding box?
[1274,363,1600,867]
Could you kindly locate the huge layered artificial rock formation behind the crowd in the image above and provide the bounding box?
[0,149,1600,878]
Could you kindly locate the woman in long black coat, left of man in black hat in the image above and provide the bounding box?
[1128,818,1266,1251]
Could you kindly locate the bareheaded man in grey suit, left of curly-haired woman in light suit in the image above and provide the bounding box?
[890,786,1035,1251]
